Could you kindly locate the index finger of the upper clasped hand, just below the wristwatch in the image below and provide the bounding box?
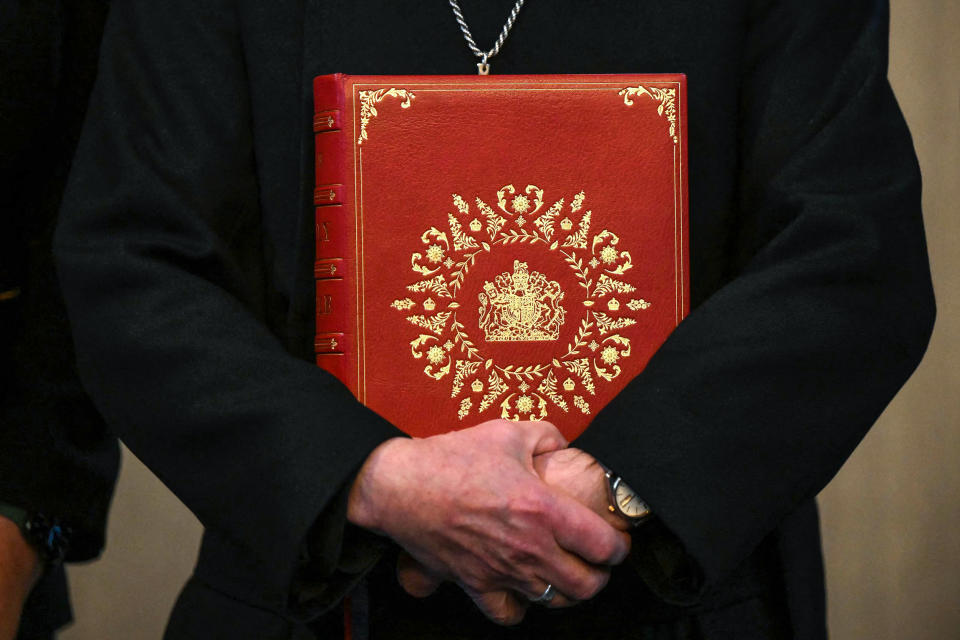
[548,491,630,565]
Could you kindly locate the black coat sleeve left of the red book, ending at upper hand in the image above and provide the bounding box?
[55,0,399,610]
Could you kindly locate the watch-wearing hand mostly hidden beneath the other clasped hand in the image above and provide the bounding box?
[397,448,630,609]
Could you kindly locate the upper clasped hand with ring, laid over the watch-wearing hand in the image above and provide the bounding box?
[347,420,629,624]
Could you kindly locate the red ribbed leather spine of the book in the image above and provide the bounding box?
[313,74,356,390]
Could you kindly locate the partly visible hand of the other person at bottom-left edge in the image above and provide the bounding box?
[0,516,40,640]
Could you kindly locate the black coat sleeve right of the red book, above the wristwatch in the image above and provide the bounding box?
[578,0,935,601]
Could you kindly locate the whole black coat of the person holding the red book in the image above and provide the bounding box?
[57,0,934,640]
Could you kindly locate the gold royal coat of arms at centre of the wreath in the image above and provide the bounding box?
[479,260,566,342]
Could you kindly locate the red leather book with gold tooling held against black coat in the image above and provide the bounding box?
[314,74,689,438]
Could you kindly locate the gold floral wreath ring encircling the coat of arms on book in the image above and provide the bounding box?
[390,184,651,420]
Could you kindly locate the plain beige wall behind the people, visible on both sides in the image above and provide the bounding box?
[62,0,960,640]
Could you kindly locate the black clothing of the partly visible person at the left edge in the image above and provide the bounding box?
[0,0,119,640]
